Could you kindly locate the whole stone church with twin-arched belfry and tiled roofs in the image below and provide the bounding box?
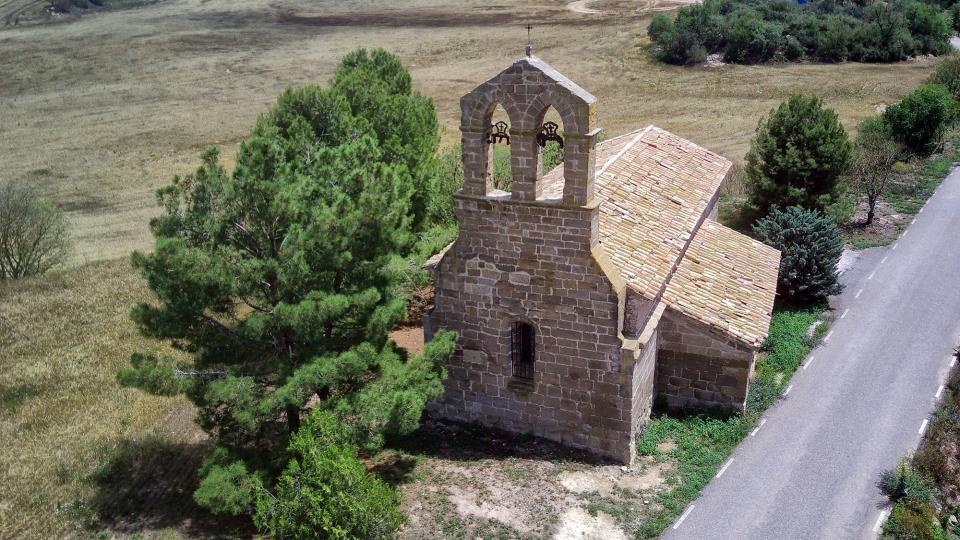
[424,49,780,463]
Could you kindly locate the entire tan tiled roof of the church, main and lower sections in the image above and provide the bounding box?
[543,126,780,346]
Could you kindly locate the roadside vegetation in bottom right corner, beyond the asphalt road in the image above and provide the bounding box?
[879,350,960,540]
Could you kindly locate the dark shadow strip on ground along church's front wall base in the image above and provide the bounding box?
[371,418,615,485]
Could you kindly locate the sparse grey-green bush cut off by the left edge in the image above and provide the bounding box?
[0,182,70,281]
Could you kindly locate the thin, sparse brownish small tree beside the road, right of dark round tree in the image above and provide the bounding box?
[849,116,901,226]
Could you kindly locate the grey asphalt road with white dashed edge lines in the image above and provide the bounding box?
[663,170,960,540]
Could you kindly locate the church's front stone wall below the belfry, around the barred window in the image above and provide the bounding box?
[429,194,634,462]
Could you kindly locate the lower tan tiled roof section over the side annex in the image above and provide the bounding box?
[663,219,780,346]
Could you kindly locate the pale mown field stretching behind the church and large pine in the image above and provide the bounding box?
[0,0,932,262]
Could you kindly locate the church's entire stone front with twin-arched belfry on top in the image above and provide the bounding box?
[427,57,632,460]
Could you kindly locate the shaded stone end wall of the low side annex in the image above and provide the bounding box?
[655,309,756,412]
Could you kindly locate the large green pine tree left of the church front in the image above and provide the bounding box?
[118,76,454,513]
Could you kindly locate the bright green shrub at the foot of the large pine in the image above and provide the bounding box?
[254,411,403,539]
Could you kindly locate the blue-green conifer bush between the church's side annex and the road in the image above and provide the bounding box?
[753,207,843,304]
